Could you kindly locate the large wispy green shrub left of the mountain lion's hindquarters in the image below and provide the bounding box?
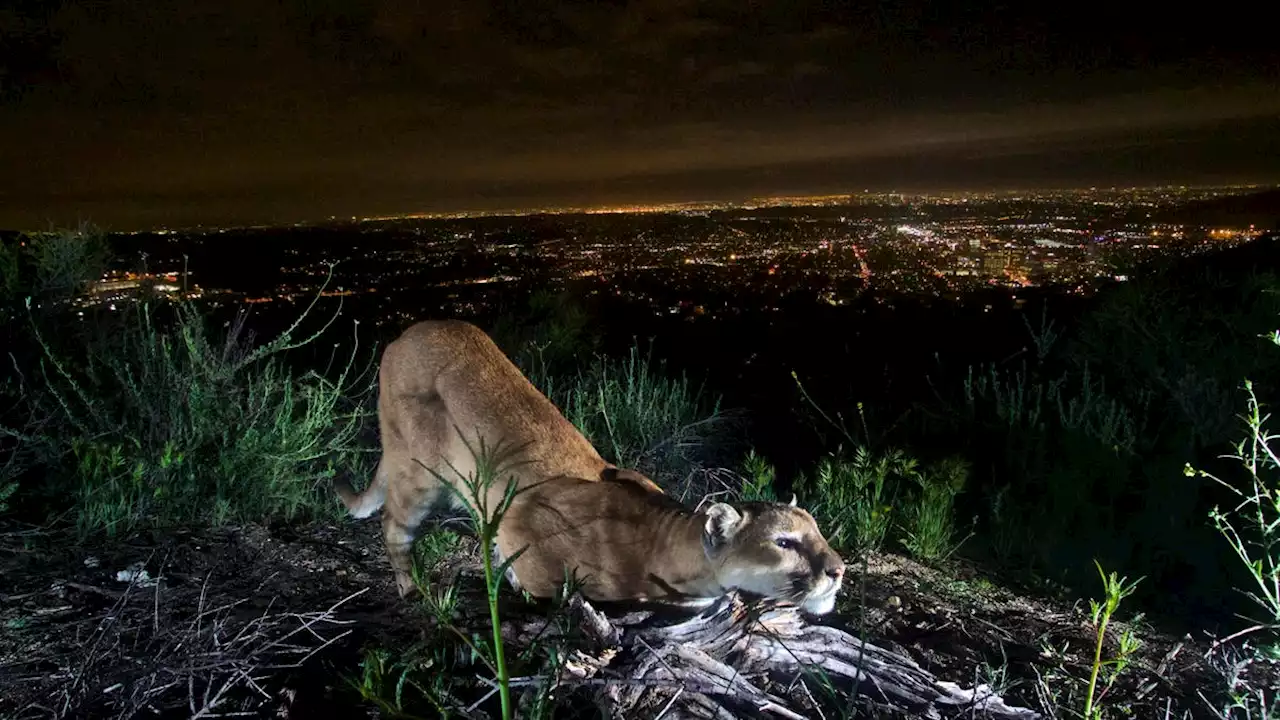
[15,285,372,532]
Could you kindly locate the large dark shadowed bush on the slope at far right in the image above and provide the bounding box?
[929,269,1280,612]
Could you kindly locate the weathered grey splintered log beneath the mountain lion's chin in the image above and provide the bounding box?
[503,593,1041,720]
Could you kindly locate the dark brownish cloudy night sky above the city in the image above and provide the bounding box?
[0,0,1280,229]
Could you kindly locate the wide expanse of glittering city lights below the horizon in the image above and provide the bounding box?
[81,187,1262,324]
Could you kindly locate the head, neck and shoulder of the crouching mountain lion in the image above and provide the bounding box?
[498,478,845,614]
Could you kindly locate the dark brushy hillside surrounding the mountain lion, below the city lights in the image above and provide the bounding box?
[0,226,1280,717]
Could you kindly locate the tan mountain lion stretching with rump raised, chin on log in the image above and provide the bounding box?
[338,320,844,612]
